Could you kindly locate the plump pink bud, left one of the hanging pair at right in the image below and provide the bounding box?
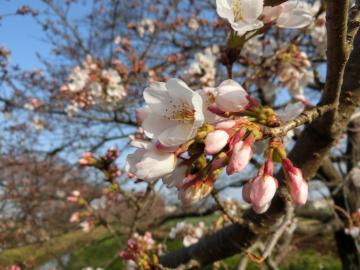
[250,175,277,214]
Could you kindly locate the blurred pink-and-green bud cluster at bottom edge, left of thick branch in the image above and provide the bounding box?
[119,232,162,270]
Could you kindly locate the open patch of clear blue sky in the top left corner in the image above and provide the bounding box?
[0,0,49,69]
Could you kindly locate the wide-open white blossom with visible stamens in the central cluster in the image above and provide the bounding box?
[143,79,204,146]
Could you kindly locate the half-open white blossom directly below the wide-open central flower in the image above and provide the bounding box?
[125,141,176,182]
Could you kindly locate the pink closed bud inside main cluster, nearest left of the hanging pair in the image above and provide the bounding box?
[226,141,253,175]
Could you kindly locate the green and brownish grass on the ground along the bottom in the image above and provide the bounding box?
[0,215,341,270]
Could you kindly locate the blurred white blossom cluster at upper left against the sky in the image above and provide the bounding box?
[61,56,126,115]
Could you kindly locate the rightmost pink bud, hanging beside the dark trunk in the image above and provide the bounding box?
[283,159,309,205]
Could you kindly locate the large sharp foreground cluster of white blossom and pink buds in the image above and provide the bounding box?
[126,79,307,213]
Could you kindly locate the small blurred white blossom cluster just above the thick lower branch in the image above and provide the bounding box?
[169,222,206,247]
